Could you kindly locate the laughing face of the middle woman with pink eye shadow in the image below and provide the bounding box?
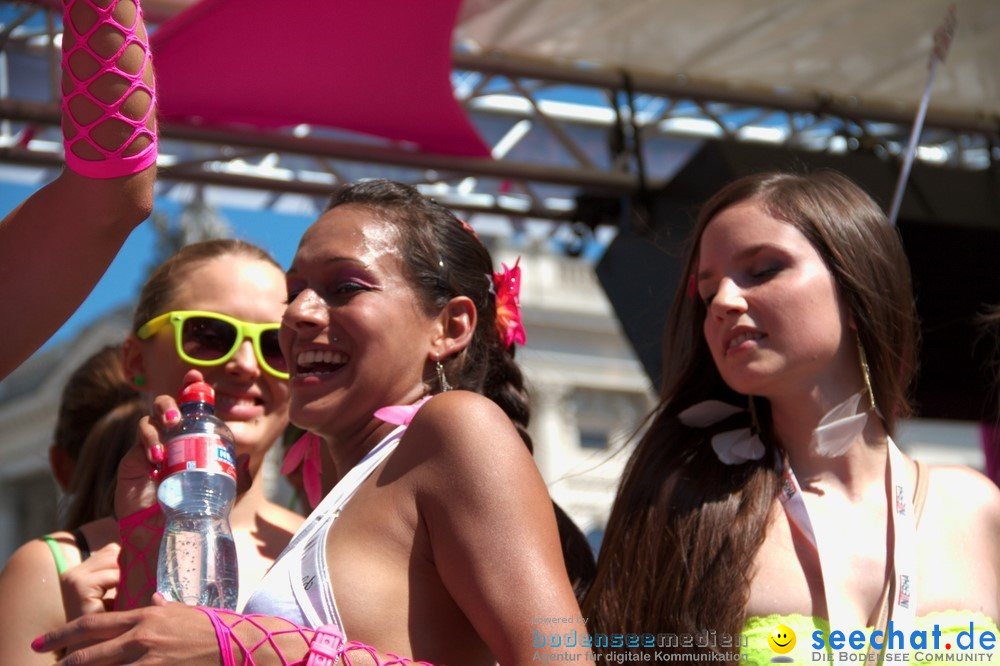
[281,204,436,435]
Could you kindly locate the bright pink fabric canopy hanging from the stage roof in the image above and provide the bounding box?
[151,0,490,156]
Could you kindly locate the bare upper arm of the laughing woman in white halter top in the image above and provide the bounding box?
[408,392,591,666]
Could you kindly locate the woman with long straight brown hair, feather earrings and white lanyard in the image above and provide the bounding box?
[584,172,1000,662]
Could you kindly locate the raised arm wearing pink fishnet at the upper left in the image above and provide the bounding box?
[0,0,156,379]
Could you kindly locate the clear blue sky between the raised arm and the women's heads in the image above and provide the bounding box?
[0,175,314,346]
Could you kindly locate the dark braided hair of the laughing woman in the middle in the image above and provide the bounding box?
[327,179,594,596]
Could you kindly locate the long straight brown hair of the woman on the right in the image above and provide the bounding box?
[584,171,918,652]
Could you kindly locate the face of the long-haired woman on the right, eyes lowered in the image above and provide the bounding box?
[697,201,860,398]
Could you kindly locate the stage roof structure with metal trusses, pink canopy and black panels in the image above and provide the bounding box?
[0,0,1000,418]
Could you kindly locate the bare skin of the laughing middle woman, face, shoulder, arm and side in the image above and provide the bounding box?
[270,205,586,664]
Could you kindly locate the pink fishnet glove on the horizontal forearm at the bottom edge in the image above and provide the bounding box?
[197,606,433,666]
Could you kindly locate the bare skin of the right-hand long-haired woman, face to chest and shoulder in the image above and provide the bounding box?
[696,200,1000,628]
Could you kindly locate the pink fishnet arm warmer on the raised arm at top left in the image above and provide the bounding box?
[62,0,157,178]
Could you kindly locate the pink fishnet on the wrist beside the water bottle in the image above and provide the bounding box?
[115,504,163,610]
